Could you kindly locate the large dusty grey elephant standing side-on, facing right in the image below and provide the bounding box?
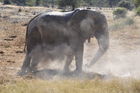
[20,10,109,75]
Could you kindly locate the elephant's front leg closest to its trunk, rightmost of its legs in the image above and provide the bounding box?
[75,44,84,73]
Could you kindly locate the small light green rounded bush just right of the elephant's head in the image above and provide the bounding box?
[113,7,127,18]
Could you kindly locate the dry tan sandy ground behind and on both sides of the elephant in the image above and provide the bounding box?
[0,5,140,79]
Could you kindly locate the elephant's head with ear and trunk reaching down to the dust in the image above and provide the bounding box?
[68,10,109,66]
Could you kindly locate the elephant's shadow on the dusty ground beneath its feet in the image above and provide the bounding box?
[32,69,106,80]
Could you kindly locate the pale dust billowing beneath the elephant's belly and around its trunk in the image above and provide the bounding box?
[27,35,140,79]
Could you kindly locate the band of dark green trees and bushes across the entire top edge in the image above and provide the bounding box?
[0,0,137,10]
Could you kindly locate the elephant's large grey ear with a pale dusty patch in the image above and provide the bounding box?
[68,10,95,42]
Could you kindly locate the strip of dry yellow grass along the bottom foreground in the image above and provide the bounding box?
[0,79,140,93]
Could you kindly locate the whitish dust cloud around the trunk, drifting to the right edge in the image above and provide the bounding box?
[84,39,140,79]
